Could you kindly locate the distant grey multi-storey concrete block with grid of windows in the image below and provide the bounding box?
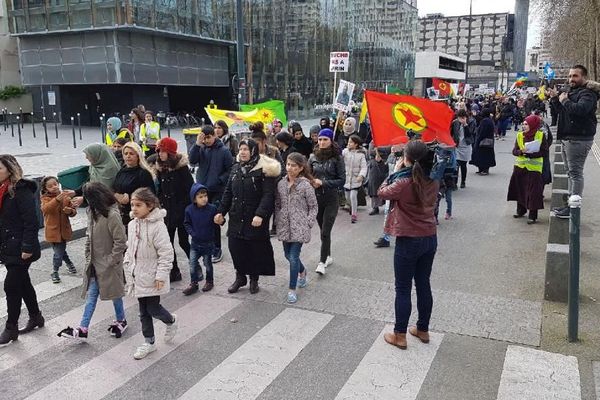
[417,6,528,87]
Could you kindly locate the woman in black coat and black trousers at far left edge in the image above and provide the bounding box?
[0,154,44,346]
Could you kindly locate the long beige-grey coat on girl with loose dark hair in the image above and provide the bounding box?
[82,204,127,300]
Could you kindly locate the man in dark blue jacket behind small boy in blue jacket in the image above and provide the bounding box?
[189,125,233,263]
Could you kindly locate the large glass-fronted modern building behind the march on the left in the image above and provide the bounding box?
[7,0,418,124]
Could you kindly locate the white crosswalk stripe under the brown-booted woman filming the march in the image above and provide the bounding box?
[336,325,444,400]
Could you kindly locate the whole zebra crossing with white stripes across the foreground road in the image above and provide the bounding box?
[0,291,581,400]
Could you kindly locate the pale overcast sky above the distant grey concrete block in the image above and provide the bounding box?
[417,0,539,47]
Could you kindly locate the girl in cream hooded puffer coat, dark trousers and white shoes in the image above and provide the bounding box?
[124,188,177,360]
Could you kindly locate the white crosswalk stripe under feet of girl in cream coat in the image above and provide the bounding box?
[28,296,240,400]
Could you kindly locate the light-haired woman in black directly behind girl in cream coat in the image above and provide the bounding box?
[113,142,156,228]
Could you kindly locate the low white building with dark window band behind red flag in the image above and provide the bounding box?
[413,51,467,97]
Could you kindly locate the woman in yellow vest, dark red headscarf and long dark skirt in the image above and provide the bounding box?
[507,115,548,224]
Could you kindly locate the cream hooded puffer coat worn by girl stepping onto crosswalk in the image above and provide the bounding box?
[124,208,174,297]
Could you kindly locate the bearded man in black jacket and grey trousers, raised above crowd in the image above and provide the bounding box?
[549,65,598,218]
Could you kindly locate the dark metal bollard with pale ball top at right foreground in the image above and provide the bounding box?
[568,194,581,342]
